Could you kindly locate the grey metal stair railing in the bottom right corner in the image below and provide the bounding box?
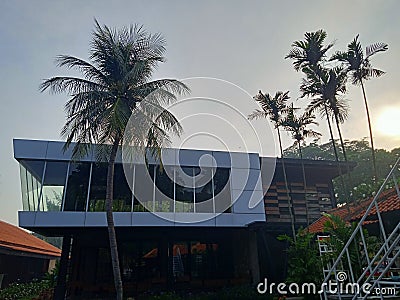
[320,158,400,300]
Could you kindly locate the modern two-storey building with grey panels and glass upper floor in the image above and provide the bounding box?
[14,140,345,295]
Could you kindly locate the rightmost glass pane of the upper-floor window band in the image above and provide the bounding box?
[213,168,231,213]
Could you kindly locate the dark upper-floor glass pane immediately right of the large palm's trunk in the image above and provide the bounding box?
[113,164,132,212]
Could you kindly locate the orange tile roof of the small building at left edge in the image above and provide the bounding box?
[0,221,61,257]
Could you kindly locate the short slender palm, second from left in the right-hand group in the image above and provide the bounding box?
[282,104,321,226]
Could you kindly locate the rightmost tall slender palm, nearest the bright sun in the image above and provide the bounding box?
[331,35,388,180]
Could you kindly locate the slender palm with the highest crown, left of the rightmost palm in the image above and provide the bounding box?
[285,29,347,200]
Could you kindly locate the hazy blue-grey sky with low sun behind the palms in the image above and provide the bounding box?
[0,0,400,224]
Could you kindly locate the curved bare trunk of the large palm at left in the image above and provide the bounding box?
[106,138,123,300]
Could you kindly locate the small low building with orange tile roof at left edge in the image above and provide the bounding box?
[0,221,61,288]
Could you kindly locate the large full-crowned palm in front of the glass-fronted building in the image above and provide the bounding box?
[40,20,189,300]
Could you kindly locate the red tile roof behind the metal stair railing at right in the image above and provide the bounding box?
[308,188,400,233]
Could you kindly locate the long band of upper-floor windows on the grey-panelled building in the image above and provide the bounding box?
[20,160,231,213]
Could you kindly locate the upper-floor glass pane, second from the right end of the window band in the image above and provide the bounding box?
[194,168,214,213]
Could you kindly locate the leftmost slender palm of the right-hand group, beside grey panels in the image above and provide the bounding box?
[249,90,296,239]
